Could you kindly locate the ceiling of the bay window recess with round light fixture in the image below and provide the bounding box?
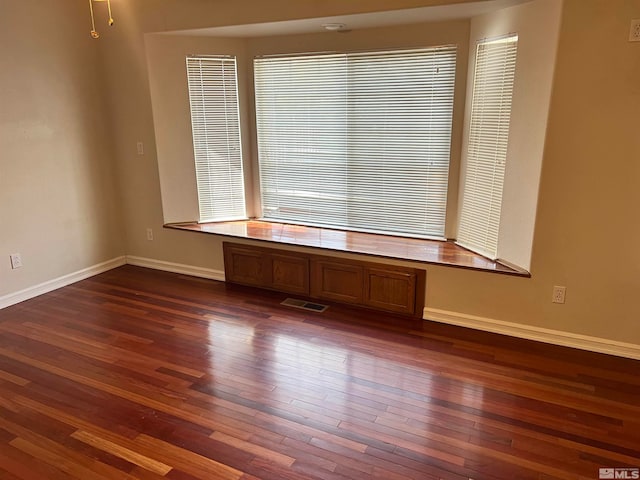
[167,0,531,37]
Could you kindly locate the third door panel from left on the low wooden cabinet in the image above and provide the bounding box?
[311,260,363,303]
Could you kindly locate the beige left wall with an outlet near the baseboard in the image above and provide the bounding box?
[0,0,124,303]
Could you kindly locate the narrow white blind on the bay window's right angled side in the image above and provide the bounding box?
[457,35,518,259]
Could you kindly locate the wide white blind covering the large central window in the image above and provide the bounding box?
[254,46,456,238]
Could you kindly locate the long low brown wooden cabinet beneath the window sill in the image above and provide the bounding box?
[223,242,426,316]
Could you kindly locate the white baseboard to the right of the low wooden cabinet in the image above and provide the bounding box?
[422,308,640,360]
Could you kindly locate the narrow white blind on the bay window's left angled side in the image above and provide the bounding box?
[187,56,246,222]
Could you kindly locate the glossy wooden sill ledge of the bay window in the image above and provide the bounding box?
[165,220,531,277]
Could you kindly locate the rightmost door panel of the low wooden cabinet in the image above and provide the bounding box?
[364,268,416,314]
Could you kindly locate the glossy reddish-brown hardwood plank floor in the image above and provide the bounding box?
[0,266,640,480]
